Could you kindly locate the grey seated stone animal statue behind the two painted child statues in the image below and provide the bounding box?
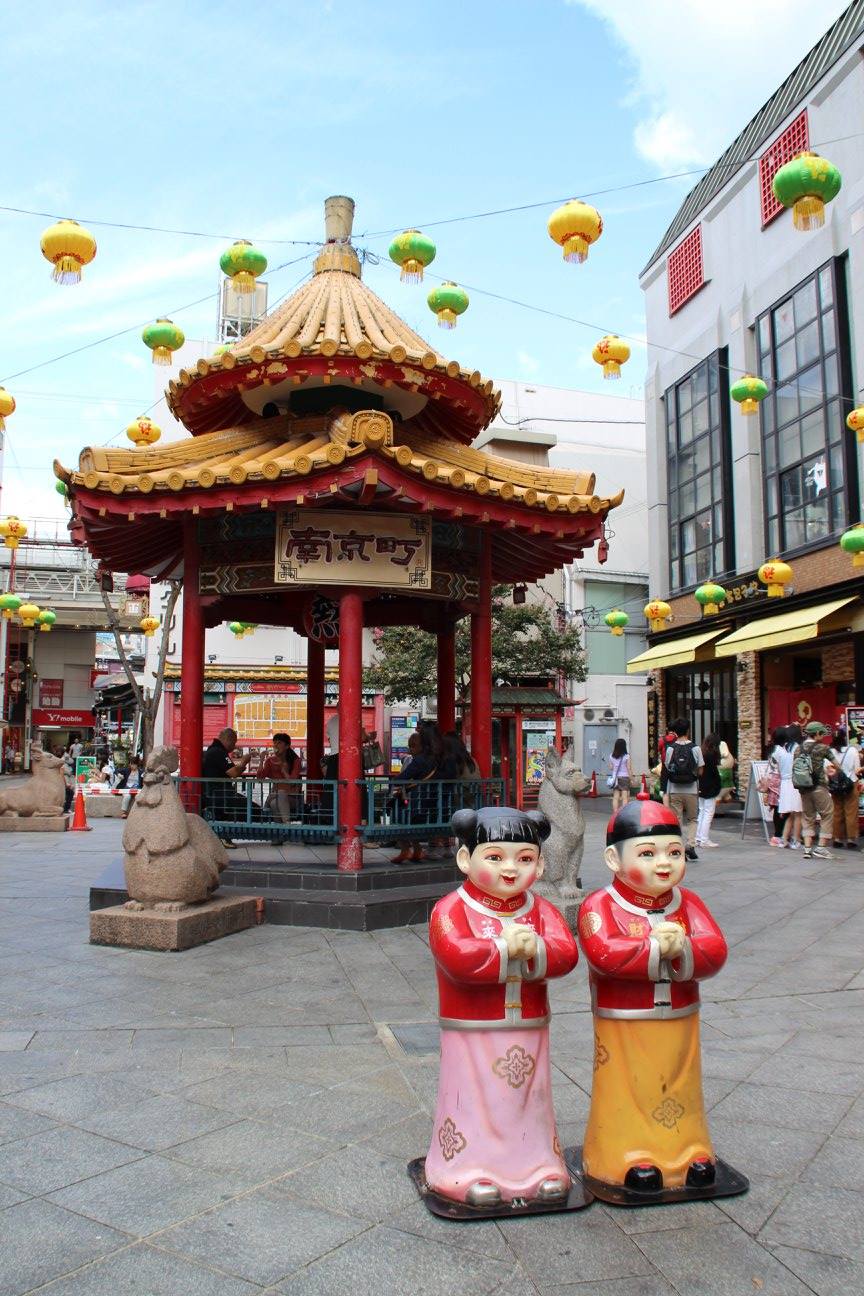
[535,748,591,931]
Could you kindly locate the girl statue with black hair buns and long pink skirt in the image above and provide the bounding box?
[412,806,580,1214]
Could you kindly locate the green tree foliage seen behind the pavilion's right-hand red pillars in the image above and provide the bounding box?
[364,586,587,705]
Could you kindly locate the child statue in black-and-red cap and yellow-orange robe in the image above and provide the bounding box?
[579,801,747,1205]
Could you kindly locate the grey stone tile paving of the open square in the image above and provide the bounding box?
[0,807,864,1296]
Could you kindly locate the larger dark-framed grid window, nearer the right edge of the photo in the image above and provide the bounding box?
[756,263,856,555]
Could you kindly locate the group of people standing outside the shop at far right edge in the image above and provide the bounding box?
[759,721,864,859]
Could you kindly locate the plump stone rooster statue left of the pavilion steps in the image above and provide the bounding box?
[123,746,228,911]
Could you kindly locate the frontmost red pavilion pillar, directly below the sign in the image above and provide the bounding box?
[337,592,363,874]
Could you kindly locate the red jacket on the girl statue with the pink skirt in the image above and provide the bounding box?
[429,880,579,1030]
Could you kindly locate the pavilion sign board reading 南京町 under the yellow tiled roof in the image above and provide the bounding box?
[275,509,431,590]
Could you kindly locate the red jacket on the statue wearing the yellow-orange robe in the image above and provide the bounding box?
[579,879,727,1020]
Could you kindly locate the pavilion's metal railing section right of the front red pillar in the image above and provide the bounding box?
[360,778,505,841]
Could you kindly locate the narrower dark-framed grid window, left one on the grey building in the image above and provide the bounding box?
[665,351,734,590]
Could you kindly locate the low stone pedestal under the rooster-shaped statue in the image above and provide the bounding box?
[89,896,255,950]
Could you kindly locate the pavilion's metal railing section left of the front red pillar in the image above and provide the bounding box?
[177,778,339,845]
